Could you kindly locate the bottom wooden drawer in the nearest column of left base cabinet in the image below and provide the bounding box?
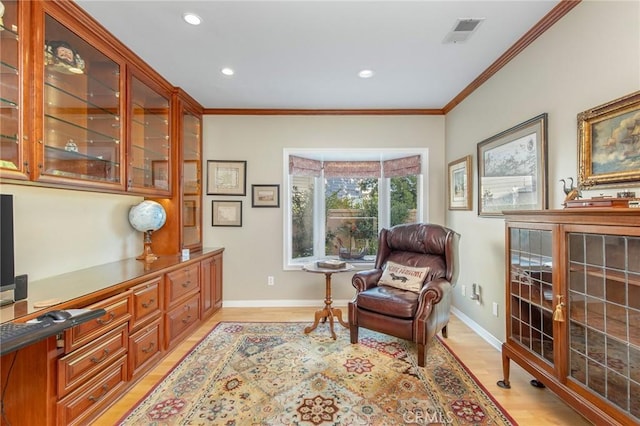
[56,356,127,425]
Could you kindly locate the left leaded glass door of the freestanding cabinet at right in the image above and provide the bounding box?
[507,225,556,371]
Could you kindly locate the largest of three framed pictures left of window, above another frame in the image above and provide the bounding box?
[207,160,247,195]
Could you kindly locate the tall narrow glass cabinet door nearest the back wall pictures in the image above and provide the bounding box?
[182,111,202,250]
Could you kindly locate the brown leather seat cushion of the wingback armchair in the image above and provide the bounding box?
[356,285,418,318]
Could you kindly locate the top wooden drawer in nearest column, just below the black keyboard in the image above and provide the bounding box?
[64,291,131,353]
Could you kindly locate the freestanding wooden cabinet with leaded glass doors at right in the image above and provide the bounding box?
[498,208,640,425]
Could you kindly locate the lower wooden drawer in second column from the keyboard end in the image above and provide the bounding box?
[129,318,163,380]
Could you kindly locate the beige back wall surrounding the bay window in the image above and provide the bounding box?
[203,116,446,306]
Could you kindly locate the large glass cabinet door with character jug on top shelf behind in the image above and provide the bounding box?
[38,14,124,187]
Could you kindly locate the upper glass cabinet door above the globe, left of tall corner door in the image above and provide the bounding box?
[128,76,171,195]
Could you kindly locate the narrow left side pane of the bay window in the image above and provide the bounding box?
[291,176,315,259]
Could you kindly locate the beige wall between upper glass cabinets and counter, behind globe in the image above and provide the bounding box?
[0,184,142,281]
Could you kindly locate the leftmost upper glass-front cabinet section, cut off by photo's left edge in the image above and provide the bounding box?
[0,0,31,180]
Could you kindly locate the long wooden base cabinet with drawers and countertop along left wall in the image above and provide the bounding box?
[0,249,223,426]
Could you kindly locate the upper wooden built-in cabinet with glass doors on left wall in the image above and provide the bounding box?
[0,0,203,255]
